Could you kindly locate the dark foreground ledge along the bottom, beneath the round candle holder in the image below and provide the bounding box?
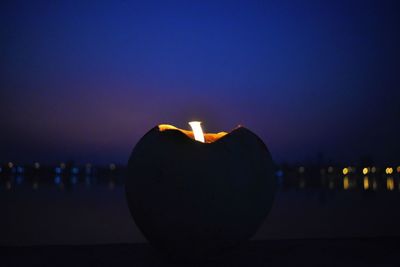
[0,237,400,267]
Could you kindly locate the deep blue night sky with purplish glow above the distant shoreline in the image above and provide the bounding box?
[0,0,400,163]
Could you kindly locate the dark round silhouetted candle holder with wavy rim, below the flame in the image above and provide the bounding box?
[126,127,276,260]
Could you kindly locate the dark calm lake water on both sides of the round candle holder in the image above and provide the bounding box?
[0,176,400,245]
